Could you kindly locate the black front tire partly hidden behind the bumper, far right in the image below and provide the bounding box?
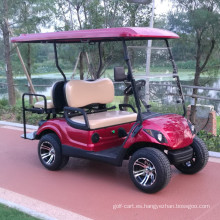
[175,136,209,174]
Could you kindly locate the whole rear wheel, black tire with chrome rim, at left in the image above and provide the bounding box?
[38,133,69,170]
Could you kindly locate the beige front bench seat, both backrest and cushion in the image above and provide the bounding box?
[65,78,137,129]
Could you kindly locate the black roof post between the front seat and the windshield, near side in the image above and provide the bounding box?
[122,39,143,124]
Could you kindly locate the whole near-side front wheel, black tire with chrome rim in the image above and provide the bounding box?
[128,147,171,193]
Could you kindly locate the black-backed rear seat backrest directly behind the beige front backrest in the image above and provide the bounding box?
[51,81,67,110]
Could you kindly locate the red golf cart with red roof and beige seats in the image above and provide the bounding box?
[11,27,208,193]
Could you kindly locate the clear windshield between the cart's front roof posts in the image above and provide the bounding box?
[125,40,186,114]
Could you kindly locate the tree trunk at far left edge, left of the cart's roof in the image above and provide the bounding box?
[2,18,16,106]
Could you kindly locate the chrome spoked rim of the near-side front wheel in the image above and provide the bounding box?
[133,158,157,186]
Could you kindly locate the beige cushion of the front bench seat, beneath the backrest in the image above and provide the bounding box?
[71,111,137,129]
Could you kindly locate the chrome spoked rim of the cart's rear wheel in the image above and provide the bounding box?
[40,141,55,165]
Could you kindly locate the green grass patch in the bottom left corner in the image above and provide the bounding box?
[0,204,38,220]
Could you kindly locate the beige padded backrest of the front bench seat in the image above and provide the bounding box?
[65,78,114,108]
